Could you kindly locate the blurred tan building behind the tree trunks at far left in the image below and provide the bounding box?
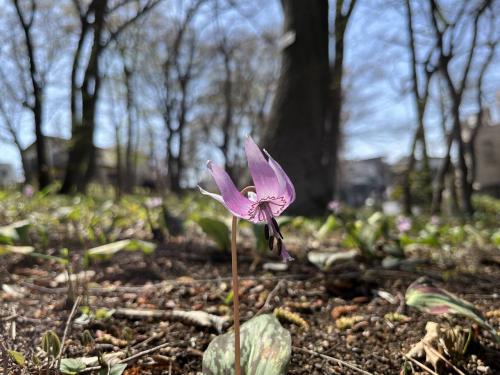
[25,137,156,186]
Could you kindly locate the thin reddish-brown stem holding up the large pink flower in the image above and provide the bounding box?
[231,186,255,375]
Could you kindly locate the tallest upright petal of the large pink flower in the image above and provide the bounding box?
[245,136,284,200]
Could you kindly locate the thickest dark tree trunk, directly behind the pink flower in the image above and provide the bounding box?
[263,0,332,215]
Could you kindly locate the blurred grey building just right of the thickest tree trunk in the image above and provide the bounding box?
[339,157,391,207]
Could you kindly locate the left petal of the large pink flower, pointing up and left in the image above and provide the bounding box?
[200,161,255,220]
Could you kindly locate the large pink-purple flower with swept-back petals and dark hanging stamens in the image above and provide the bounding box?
[199,137,295,262]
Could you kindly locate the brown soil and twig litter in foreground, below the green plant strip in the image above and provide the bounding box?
[0,241,500,375]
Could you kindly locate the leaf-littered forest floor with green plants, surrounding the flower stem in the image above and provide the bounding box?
[0,192,500,375]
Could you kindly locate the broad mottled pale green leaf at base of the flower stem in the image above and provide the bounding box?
[203,314,292,375]
